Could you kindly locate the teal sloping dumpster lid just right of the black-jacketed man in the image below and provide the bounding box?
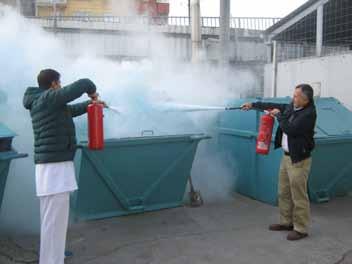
[316,98,352,137]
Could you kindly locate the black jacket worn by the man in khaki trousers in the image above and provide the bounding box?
[253,102,317,163]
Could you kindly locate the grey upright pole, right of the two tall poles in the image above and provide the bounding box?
[220,0,230,65]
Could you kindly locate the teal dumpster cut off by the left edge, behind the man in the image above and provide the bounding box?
[0,123,27,208]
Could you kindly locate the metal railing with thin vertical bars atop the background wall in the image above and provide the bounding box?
[29,16,280,31]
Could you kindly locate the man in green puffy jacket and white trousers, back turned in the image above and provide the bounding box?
[23,69,97,264]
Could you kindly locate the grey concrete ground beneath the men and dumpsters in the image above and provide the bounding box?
[0,196,352,264]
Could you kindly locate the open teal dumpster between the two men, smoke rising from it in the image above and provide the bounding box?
[71,134,209,220]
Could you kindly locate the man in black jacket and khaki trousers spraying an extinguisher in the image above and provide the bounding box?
[242,84,317,240]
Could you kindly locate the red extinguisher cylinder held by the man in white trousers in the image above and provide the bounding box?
[87,103,104,150]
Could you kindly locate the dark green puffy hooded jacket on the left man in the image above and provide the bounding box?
[23,79,96,164]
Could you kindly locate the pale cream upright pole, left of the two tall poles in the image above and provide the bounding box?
[191,0,202,63]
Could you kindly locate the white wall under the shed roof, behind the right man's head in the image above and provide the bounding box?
[264,53,352,109]
